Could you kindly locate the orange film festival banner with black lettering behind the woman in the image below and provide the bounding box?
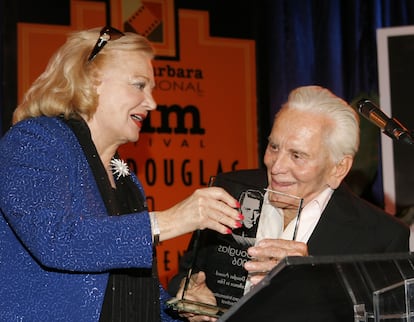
[18,0,258,285]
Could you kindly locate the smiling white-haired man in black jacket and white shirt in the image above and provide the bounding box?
[168,86,409,321]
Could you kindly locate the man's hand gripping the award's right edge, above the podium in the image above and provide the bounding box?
[244,239,308,285]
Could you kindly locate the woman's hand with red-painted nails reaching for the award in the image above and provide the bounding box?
[156,187,243,241]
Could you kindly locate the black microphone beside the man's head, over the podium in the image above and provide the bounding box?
[357,98,414,144]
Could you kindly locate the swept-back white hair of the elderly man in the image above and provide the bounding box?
[276,85,360,162]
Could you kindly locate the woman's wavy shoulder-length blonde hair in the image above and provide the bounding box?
[13,28,154,124]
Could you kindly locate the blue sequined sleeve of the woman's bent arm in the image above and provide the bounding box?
[0,117,152,272]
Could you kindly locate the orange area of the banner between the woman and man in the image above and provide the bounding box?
[120,10,258,284]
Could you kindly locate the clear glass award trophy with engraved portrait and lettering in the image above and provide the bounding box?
[167,172,303,317]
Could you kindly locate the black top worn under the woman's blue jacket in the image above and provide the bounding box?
[65,119,160,322]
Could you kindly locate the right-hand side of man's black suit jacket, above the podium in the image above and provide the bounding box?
[308,184,410,255]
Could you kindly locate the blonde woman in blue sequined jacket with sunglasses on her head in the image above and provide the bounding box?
[0,27,242,322]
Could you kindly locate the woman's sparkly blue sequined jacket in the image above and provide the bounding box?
[0,117,175,322]
